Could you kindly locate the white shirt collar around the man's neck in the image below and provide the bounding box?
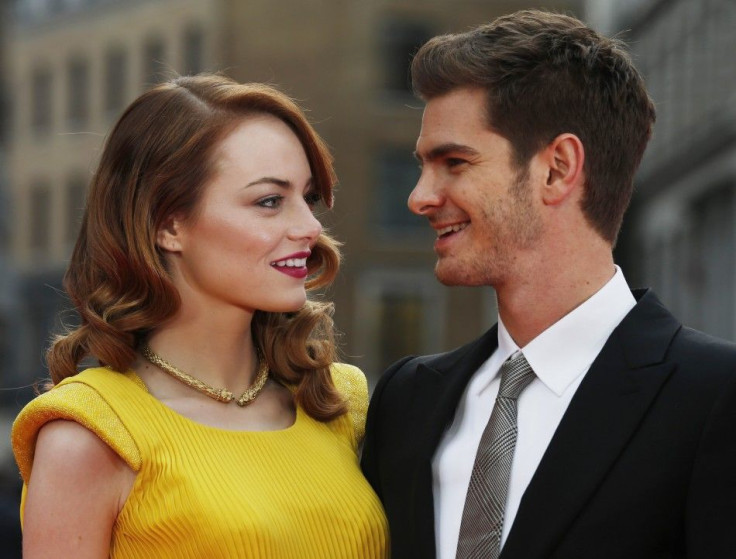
[490,266,636,396]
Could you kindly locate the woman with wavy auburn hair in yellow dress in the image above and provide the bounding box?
[13,76,386,559]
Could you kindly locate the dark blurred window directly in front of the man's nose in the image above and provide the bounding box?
[373,146,429,234]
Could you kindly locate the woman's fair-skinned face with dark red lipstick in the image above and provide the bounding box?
[164,115,322,312]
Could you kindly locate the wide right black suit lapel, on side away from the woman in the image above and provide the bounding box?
[501,292,681,559]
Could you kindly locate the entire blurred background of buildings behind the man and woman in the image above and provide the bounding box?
[0,0,736,558]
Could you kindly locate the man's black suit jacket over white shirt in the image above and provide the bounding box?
[362,291,736,559]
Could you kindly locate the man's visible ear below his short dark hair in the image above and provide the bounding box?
[542,133,585,206]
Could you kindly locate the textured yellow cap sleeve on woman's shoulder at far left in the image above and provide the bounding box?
[11,368,141,482]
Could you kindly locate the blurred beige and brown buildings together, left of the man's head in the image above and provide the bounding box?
[5,0,579,402]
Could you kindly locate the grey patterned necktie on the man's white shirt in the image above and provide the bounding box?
[457,353,534,559]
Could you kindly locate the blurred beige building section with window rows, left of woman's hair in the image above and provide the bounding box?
[5,0,218,398]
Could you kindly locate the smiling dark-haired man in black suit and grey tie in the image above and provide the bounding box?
[363,11,736,559]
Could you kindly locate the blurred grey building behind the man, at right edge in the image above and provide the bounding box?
[617,0,736,340]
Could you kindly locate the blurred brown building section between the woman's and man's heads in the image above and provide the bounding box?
[218,0,576,382]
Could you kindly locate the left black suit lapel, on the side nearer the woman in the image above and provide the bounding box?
[412,326,498,557]
